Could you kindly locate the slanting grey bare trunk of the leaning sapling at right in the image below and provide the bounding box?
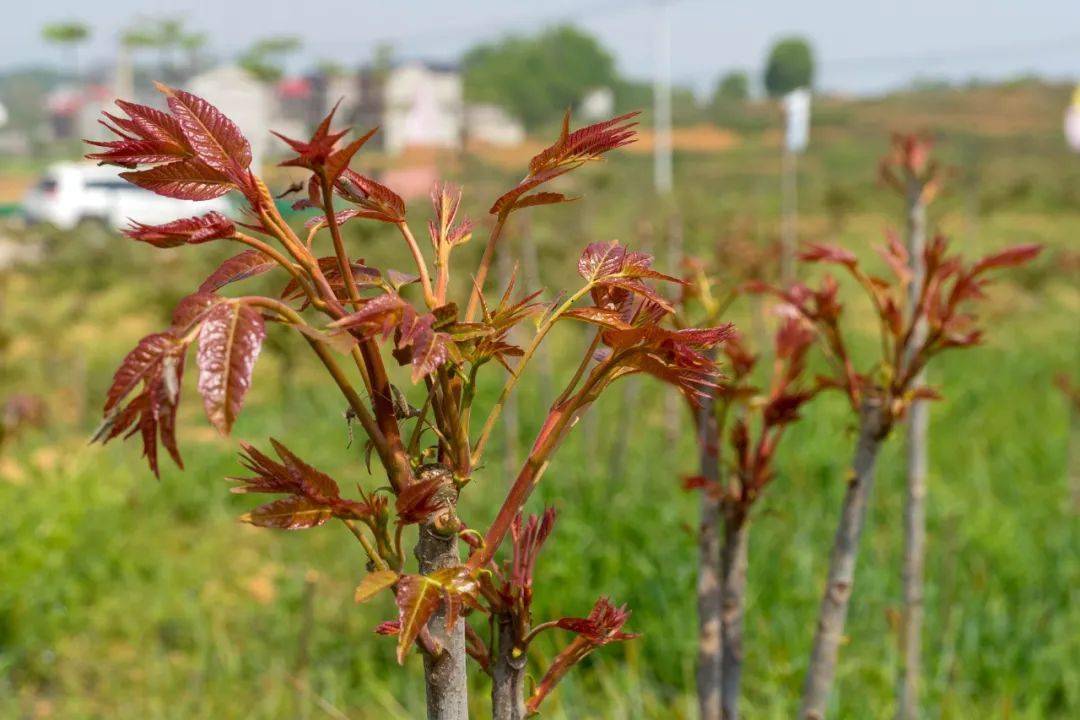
[799,399,889,720]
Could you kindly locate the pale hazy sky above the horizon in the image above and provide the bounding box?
[12,0,1080,92]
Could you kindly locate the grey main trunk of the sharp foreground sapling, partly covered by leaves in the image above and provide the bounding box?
[416,466,469,720]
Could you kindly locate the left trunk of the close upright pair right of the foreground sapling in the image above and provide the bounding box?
[698,397,723,720]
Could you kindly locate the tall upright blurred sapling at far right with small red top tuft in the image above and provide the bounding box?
[880,135,941,720]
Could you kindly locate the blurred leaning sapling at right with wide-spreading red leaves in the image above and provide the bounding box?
[757,236,1041,720]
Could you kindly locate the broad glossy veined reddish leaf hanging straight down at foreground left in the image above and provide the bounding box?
[197,302,266,435]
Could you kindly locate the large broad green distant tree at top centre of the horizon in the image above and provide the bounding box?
[463,25,618,127]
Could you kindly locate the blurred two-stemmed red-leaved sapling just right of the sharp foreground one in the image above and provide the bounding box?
[684,289,816,720]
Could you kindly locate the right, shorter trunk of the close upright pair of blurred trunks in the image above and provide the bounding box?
[721,511,750,720]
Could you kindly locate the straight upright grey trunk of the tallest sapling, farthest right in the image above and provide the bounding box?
[896,180,930,720]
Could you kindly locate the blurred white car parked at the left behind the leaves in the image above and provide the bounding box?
[23,163,232,230]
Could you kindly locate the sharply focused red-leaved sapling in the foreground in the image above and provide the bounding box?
[89,86,728,720]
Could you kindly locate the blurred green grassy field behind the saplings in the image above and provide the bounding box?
[0,81,1080,720]
